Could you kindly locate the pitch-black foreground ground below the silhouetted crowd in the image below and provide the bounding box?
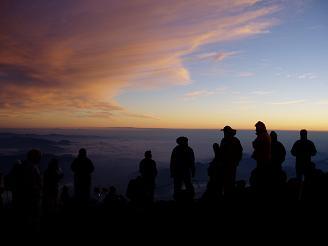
[0,190,328,242]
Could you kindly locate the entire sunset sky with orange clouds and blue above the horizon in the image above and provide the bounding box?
[0,0,328,130]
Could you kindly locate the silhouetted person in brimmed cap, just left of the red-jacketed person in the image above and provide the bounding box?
[220,126,243,195]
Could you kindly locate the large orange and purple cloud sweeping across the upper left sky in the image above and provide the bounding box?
[0,0,280,125]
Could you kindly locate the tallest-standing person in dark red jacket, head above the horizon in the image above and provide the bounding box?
[252,121,271,167]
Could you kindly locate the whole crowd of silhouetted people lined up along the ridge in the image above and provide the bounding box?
[0,121,328,234]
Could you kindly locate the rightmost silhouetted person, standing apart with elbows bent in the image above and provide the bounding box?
[291,129,317,180]
